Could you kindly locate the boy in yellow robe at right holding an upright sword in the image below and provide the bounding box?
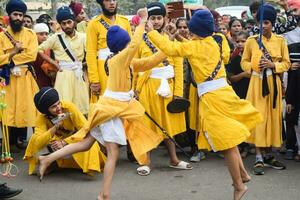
[241,4,290,175]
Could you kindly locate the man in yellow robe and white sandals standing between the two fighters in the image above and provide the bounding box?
[136,2,192,176]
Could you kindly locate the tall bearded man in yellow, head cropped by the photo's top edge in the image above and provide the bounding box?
[86,0,131,103]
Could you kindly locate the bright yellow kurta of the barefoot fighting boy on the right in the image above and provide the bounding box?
[148,31,262,151]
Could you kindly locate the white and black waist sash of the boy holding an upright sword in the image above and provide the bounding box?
[252,68,278,108]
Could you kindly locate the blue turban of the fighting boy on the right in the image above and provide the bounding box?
[189,10,215,37]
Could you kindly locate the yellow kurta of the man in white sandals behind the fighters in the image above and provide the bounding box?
[136,35,186,136]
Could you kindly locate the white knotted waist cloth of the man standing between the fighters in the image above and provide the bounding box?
[150,65,175,98]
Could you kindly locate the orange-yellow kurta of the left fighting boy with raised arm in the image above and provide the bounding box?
[82,25,165,164]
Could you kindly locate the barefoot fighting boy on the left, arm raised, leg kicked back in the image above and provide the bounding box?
[39,9,165,200]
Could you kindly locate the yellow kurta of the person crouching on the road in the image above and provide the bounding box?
[24,101,106,175]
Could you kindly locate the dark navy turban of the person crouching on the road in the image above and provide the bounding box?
[34,87,59,115]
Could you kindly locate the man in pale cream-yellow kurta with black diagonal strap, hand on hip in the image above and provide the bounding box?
[39,6,89,114]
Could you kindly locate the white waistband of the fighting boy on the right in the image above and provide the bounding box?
[197,78,228,97]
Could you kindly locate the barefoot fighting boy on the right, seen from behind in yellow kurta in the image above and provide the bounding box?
[147,10,262,200]
